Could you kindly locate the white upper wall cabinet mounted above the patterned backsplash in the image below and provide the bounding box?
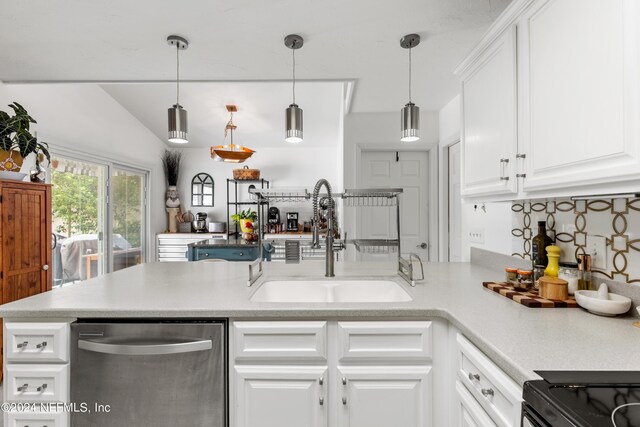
[457,0,640,200]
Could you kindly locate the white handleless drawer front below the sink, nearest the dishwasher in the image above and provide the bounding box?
[232,322,327,362]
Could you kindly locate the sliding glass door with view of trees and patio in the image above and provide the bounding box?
[51,154,148,287]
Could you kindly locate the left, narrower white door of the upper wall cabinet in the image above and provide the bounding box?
[461,26,518,196]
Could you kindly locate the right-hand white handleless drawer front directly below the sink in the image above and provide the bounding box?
[338,322,433,363]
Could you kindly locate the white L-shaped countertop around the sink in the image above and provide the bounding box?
[0,261,640,384]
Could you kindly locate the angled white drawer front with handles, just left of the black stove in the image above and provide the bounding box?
[457,334,522,427]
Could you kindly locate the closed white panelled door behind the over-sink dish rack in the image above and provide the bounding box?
[357,151,429,261]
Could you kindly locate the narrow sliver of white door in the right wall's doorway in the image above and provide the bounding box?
[448,143,462,262]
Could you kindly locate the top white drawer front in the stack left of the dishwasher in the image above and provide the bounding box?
[4,322,69,362]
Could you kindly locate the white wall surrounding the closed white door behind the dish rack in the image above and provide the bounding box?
[344,109,438,260]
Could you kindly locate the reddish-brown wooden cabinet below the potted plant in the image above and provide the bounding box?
[2,186,51,304]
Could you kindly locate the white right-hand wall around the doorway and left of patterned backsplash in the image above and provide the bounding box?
[438,95,512,261]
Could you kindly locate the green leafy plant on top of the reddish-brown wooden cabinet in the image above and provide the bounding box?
[0,102,51,166]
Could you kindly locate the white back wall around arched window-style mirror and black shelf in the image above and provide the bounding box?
[178,145,341,226]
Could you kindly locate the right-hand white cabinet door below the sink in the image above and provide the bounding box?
[335,366,433,427]
